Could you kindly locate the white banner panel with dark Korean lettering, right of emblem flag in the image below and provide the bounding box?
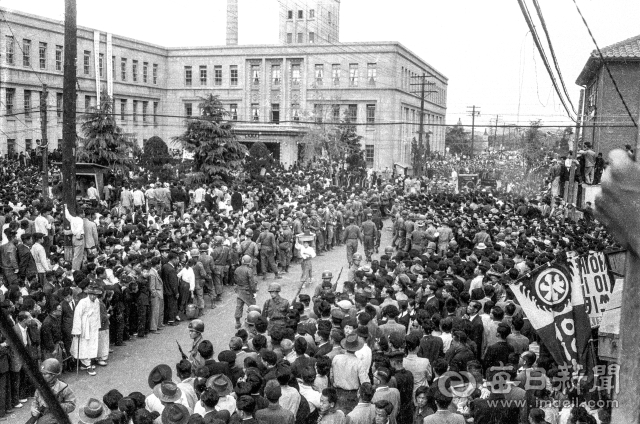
[571,252,613,328]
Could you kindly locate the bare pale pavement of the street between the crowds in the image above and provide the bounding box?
[7,220,391,423]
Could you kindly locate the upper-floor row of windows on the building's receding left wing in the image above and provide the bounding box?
[5,35,158,85]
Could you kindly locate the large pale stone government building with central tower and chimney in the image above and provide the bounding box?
[0,0,448,170]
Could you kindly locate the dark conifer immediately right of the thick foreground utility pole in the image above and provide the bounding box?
[78,93,134,170]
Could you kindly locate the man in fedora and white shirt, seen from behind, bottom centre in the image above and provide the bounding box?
[331,333,369,414]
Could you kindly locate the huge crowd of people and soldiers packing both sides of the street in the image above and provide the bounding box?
[0,147,615,424]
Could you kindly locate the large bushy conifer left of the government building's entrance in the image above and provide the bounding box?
[174,94,247,181]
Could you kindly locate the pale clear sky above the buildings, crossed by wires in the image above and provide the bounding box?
[0,0,640,126]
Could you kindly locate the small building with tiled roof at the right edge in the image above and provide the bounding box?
[576,35,640,157]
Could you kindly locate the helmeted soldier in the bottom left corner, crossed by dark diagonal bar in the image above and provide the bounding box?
[29,358,76,423]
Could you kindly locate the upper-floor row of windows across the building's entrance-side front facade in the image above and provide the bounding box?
[184,63,378,87]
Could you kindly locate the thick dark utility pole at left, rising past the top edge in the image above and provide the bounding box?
[62,0,78,215]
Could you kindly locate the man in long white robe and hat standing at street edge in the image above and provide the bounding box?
[71,284,102,375]
